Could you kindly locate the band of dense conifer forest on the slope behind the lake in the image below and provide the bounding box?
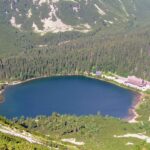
[0,27,150,79]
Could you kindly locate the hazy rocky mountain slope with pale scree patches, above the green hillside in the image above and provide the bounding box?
[0,0,150,35]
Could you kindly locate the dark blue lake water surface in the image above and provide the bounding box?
[0,76,136,118]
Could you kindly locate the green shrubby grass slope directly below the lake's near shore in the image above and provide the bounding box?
[12,112,150,150]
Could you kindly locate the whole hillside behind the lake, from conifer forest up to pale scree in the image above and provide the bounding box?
[0,0,150,80]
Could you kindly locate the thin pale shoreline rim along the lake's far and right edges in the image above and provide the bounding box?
[0,74,144,123]
